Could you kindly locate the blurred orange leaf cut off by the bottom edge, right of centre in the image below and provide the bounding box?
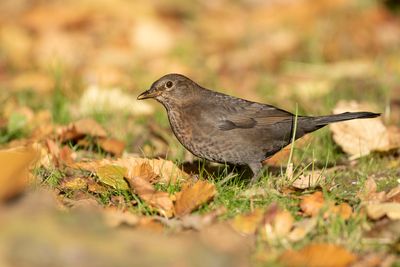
[280,243,357,267]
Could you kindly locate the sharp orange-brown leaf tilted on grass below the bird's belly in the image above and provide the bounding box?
[175,180,217,217]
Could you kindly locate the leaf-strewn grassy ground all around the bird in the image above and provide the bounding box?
[0,0,400,266]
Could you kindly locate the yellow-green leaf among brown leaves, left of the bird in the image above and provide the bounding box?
[96,165,129,190]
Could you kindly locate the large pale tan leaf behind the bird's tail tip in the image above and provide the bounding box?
[329,101,390,159]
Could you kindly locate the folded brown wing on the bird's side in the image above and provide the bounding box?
[218,101,294,131]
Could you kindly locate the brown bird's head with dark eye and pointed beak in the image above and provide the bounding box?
[137,74,197,104]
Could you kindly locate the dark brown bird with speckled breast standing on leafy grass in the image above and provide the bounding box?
[137,74,380,182]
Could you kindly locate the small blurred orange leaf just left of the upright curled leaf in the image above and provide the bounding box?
[231,209,264,235]
